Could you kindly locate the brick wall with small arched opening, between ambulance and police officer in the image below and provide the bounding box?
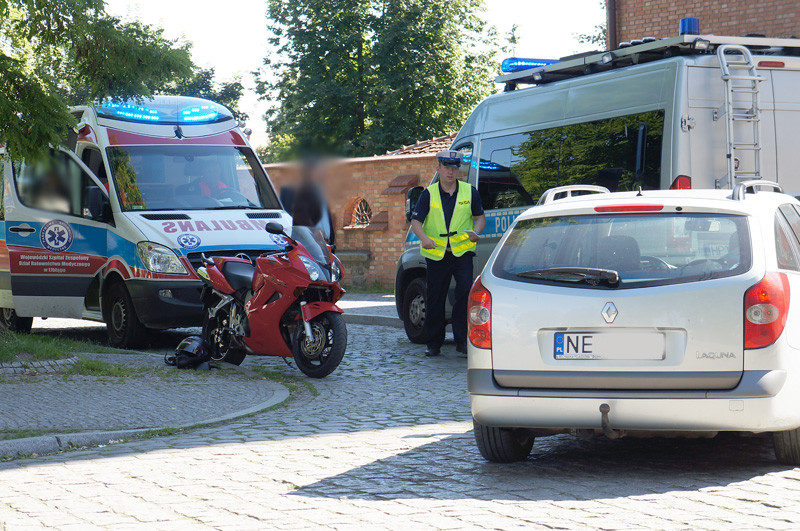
[265,154,437,289]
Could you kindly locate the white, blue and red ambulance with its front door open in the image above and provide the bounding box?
[0,96,291,346]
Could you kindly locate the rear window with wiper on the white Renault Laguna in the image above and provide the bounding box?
[492,213,751,289]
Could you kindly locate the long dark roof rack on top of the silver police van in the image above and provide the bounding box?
[495,35,800,92]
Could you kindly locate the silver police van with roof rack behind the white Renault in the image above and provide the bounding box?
[395,30,800,343]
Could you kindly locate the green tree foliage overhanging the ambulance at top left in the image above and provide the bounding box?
[0,0,192,162]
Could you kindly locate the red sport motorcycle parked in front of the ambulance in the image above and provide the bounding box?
[197,222,347,378]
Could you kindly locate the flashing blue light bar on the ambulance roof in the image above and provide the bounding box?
[95,96,233,125]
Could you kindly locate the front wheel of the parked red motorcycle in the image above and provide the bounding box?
[292,312,347,378]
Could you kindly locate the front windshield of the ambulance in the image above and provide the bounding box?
[107,145,280,210]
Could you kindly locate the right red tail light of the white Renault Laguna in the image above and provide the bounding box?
[744,273,789,349]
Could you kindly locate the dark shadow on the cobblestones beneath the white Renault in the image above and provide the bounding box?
[292,432,791,501]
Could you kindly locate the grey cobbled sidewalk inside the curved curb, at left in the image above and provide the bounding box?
[0,354,284,433]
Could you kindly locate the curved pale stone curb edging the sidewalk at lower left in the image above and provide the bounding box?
[0,376,291,457]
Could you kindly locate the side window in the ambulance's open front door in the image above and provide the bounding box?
[16,151,97,218]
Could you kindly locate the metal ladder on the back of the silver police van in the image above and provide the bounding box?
[714,44,766,188]
